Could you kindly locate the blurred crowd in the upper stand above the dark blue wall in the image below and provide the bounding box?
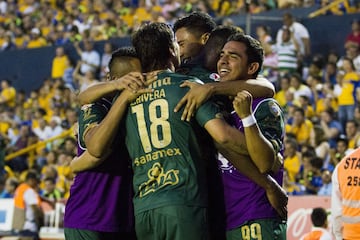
[0,0,359,51]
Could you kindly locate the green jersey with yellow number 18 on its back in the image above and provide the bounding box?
[126,71,220,214]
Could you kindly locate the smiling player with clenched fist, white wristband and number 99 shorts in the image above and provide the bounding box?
[218,34,286,239]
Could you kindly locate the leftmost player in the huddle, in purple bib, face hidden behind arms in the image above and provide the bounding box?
[64,48,148,240]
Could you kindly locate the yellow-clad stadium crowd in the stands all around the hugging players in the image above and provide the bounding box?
[0,0,360,233]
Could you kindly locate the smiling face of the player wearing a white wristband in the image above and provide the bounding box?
[217,41,248,81]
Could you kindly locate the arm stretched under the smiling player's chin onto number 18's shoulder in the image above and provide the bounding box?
[174,77,275,121]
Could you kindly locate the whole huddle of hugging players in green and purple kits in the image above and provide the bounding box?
[64,12,287,240]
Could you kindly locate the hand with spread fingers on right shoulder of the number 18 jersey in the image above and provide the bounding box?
[174,81,211,122]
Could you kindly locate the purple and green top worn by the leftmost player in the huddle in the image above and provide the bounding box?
[64,99,133,232]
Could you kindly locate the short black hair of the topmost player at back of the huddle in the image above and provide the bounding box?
[173,12,217,37]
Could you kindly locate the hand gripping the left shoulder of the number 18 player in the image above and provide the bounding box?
[112,72,145,92]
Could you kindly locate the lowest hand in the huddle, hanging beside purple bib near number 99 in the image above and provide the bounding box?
[265,175,288,220]
